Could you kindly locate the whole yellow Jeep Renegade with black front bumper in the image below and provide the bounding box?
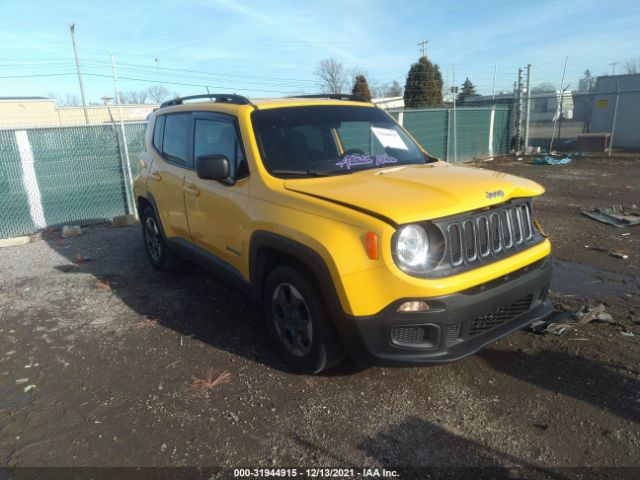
[134,94,552,372]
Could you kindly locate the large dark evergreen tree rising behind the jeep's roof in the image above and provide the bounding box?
[404,57,442,108]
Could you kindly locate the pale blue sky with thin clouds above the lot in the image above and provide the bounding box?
[0,0,640,101]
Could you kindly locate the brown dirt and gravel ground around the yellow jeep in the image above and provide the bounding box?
[0,158,640,478]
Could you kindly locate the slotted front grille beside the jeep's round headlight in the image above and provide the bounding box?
[446,203,533,267]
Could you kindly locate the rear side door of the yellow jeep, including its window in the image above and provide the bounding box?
[147,113,192,242]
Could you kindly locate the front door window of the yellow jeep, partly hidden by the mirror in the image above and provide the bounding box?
[193,118,249,178]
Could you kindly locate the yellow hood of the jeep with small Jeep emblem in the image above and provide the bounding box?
[284,162,544,224]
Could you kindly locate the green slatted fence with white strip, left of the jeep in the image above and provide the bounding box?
[0,123,146,238]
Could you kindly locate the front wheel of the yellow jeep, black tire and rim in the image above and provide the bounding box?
[263,265,345,373]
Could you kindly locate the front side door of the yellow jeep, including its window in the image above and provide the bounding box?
[185,112,249,270]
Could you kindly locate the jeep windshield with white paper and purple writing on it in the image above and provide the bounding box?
[251,105,427,176]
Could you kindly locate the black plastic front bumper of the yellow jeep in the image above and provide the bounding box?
[339,255,553,366]
